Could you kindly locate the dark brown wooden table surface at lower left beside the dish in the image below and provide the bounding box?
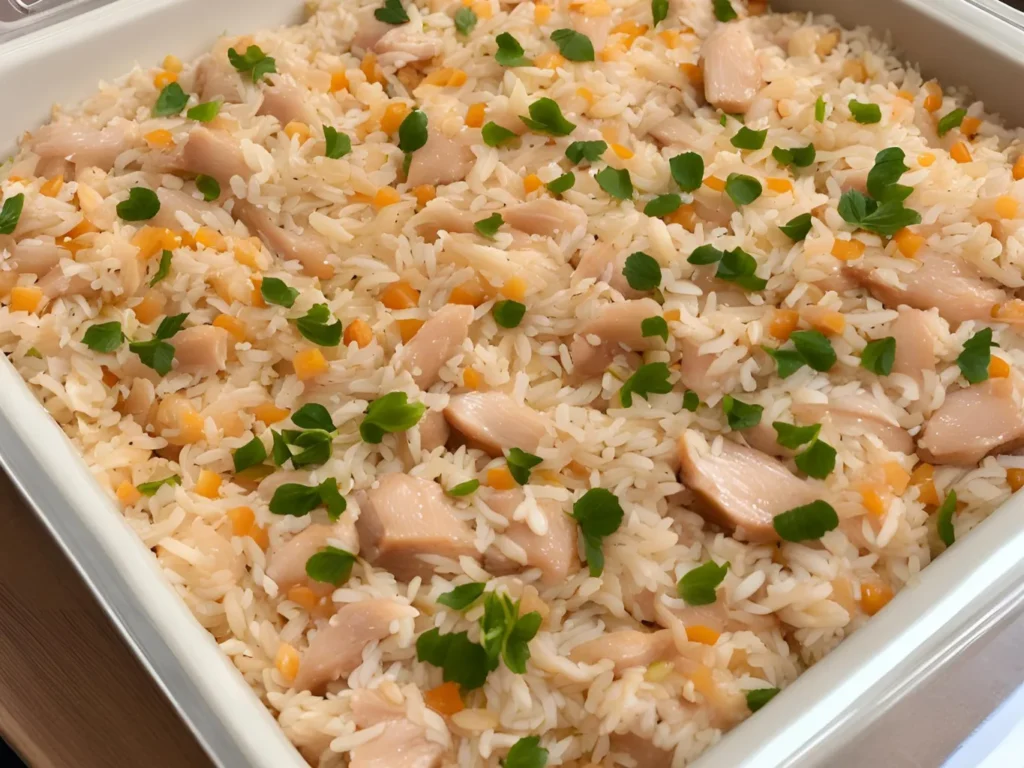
[0,470,211,768]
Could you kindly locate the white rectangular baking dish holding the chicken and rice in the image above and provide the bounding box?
[6,0,1024,768]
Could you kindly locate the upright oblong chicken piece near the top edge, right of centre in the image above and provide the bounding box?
[700,24,764,115]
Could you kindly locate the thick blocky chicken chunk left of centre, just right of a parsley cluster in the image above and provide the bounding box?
[356,473,480,582]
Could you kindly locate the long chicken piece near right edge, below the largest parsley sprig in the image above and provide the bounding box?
[844,252,1007,325]
